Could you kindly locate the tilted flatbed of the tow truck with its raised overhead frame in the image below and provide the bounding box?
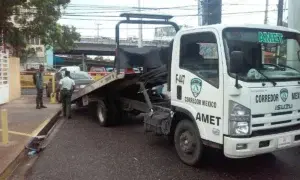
[71,13,179,106]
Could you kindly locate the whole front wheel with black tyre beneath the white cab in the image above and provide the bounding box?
[174,120,203,166]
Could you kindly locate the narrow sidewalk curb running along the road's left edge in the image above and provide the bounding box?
[0,109,61,180]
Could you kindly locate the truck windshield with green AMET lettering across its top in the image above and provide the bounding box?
[223,28,300,81]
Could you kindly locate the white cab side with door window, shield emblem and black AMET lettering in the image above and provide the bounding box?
[171,29,223,144]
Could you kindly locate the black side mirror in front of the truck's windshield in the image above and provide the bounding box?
[229,51,244,73]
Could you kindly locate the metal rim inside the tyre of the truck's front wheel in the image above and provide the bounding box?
[179,130,196,155]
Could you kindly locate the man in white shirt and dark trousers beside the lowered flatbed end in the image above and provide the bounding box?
[59,71,75,119]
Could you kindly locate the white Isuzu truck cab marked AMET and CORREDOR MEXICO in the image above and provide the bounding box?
[170,25,300,160]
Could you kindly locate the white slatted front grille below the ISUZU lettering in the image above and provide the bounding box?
[251,110,300,132]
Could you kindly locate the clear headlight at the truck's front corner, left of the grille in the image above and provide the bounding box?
[229,100,251,136]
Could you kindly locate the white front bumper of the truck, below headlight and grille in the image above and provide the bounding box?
[224,130,300,158]
